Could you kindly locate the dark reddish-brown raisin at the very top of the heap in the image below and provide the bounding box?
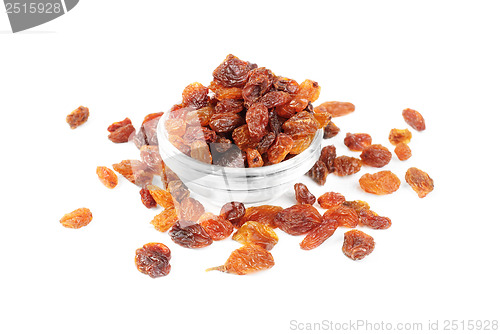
[213,54,257,87]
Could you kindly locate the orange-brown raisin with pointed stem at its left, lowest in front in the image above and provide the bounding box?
[207,245,274,275]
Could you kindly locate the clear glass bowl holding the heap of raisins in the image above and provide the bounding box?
[157,113,323,204]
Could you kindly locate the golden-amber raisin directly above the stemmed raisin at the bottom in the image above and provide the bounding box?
[233,221,278,251]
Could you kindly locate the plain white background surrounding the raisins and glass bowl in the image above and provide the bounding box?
[0,0,500,333]
